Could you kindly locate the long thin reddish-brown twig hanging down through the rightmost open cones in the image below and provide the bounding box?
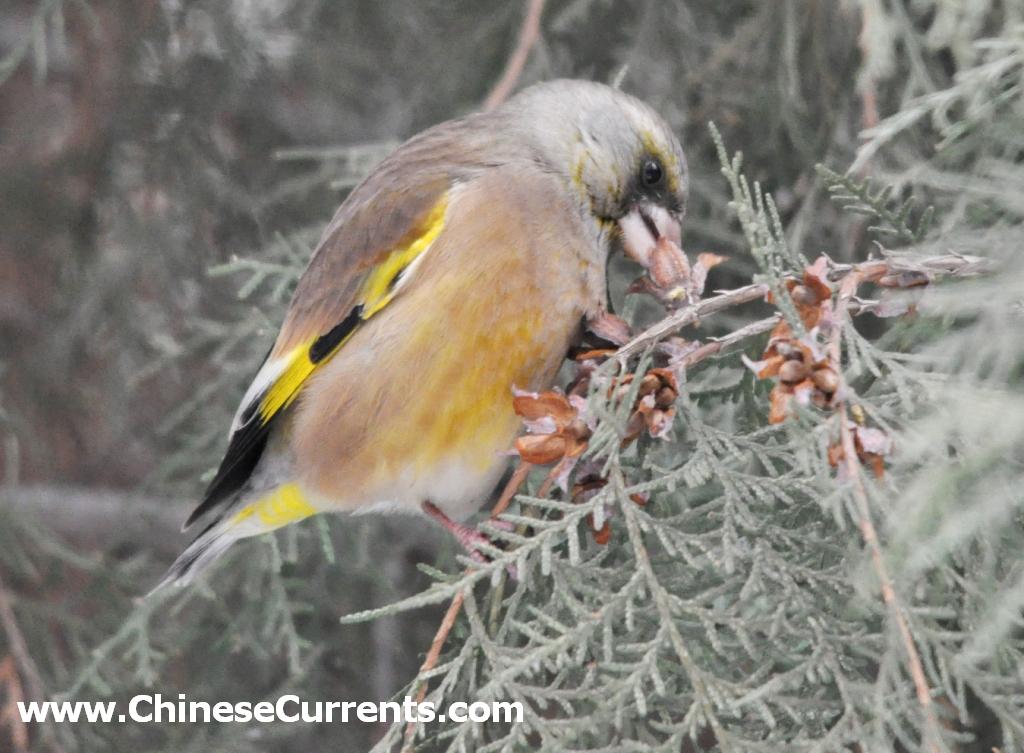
[828,270,939,753]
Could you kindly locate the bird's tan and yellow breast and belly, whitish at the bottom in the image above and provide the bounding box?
[294,165,595,515]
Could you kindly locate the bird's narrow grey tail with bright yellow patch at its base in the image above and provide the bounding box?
[150,483,317,594]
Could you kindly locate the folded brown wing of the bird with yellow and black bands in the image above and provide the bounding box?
[185,116,503,528]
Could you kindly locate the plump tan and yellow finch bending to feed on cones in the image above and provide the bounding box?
[154,79,689,590]
